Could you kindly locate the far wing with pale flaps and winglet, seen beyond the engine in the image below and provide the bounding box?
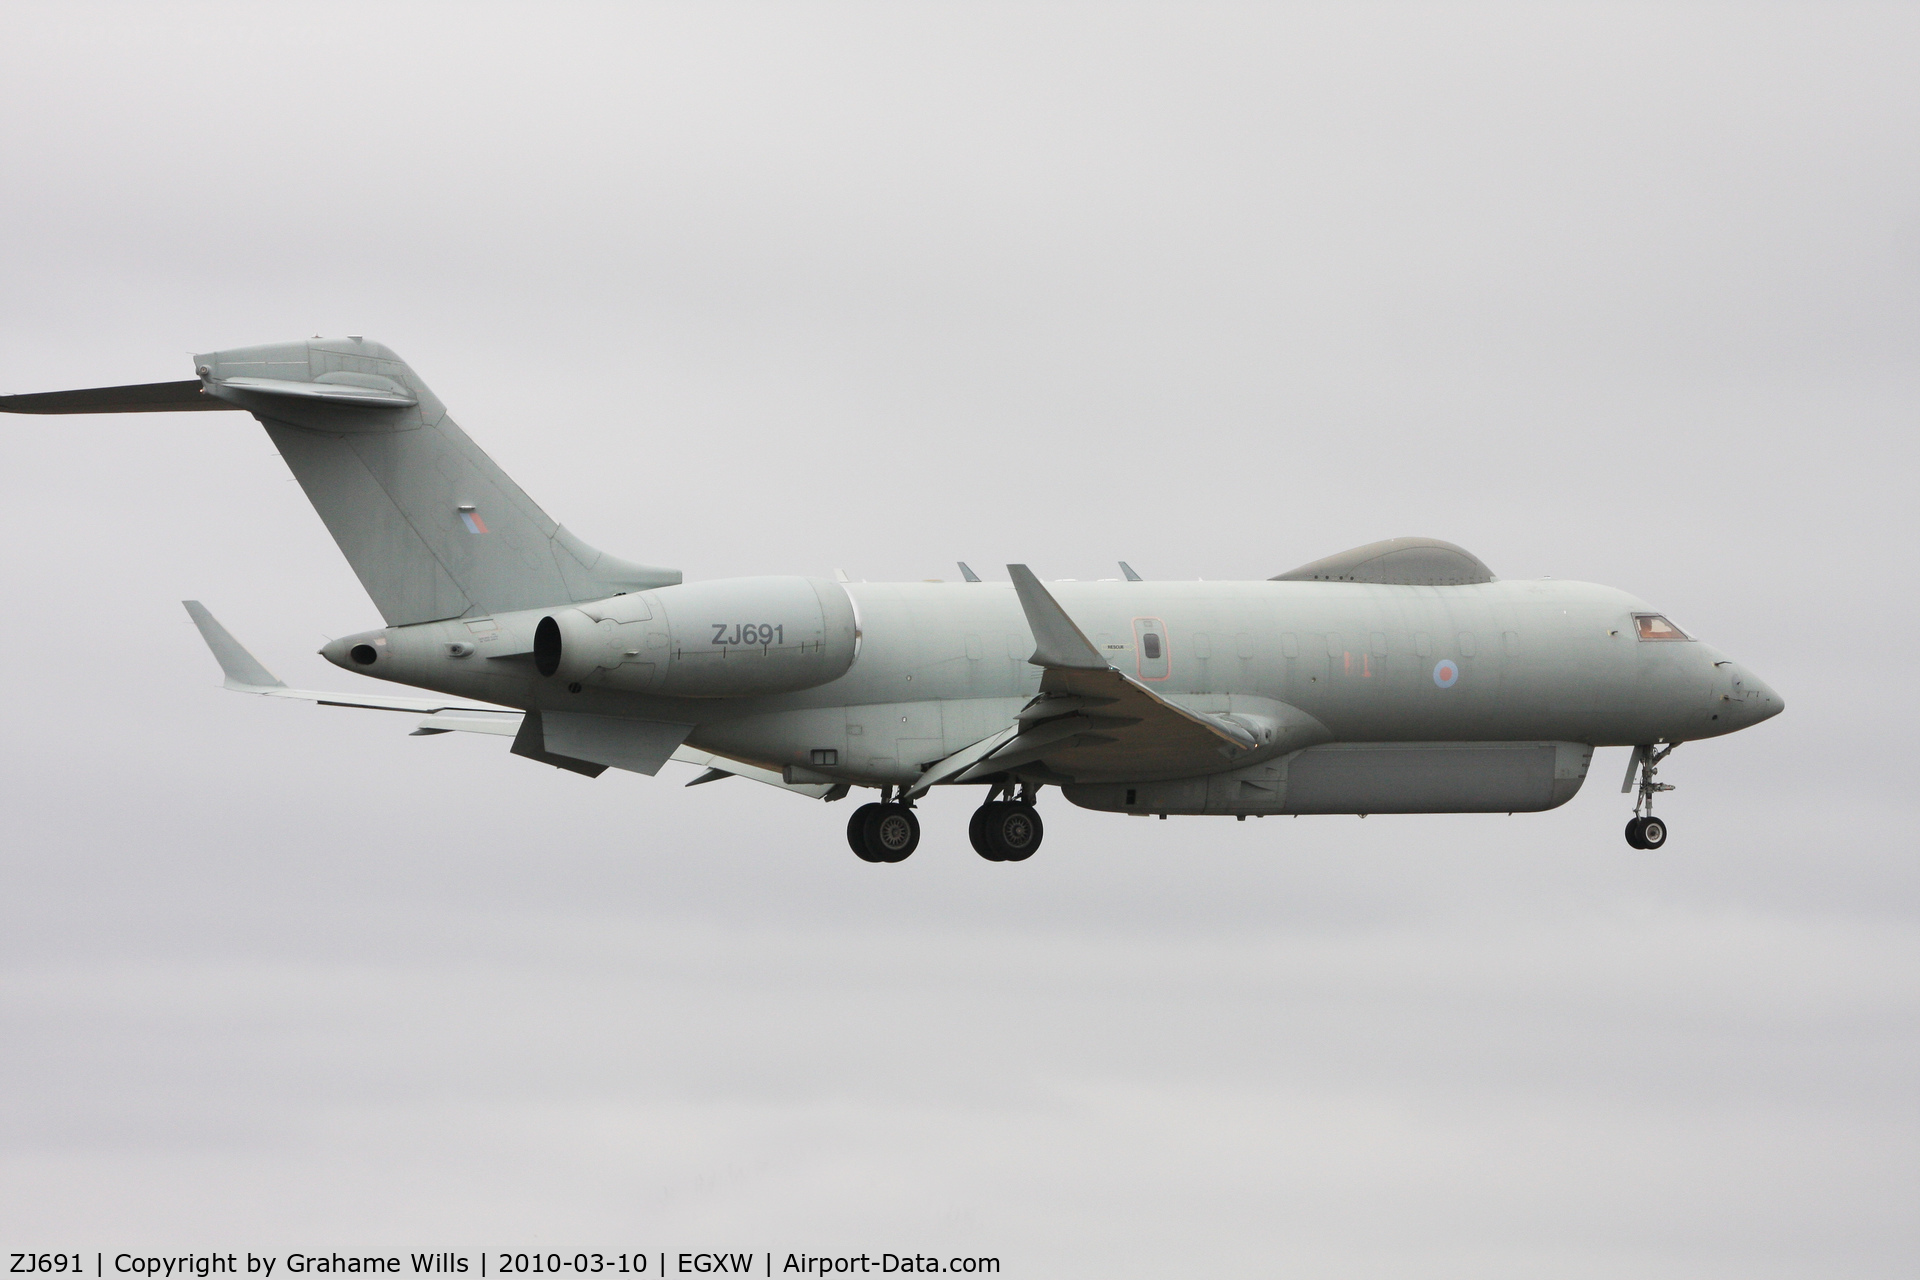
[191,601,847,800]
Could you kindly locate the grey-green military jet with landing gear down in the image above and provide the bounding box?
[0,338,1782,864]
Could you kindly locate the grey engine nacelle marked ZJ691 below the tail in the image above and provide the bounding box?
[534,578,854,699]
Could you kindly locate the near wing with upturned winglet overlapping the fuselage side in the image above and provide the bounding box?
[948,564,1327,793]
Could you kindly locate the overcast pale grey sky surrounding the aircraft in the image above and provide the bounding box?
[0,2,1920,1280]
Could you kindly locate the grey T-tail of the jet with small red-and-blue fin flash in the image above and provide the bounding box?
[0,338,680,626]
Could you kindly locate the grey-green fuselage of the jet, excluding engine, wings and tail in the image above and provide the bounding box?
[323,580,1782,787]
